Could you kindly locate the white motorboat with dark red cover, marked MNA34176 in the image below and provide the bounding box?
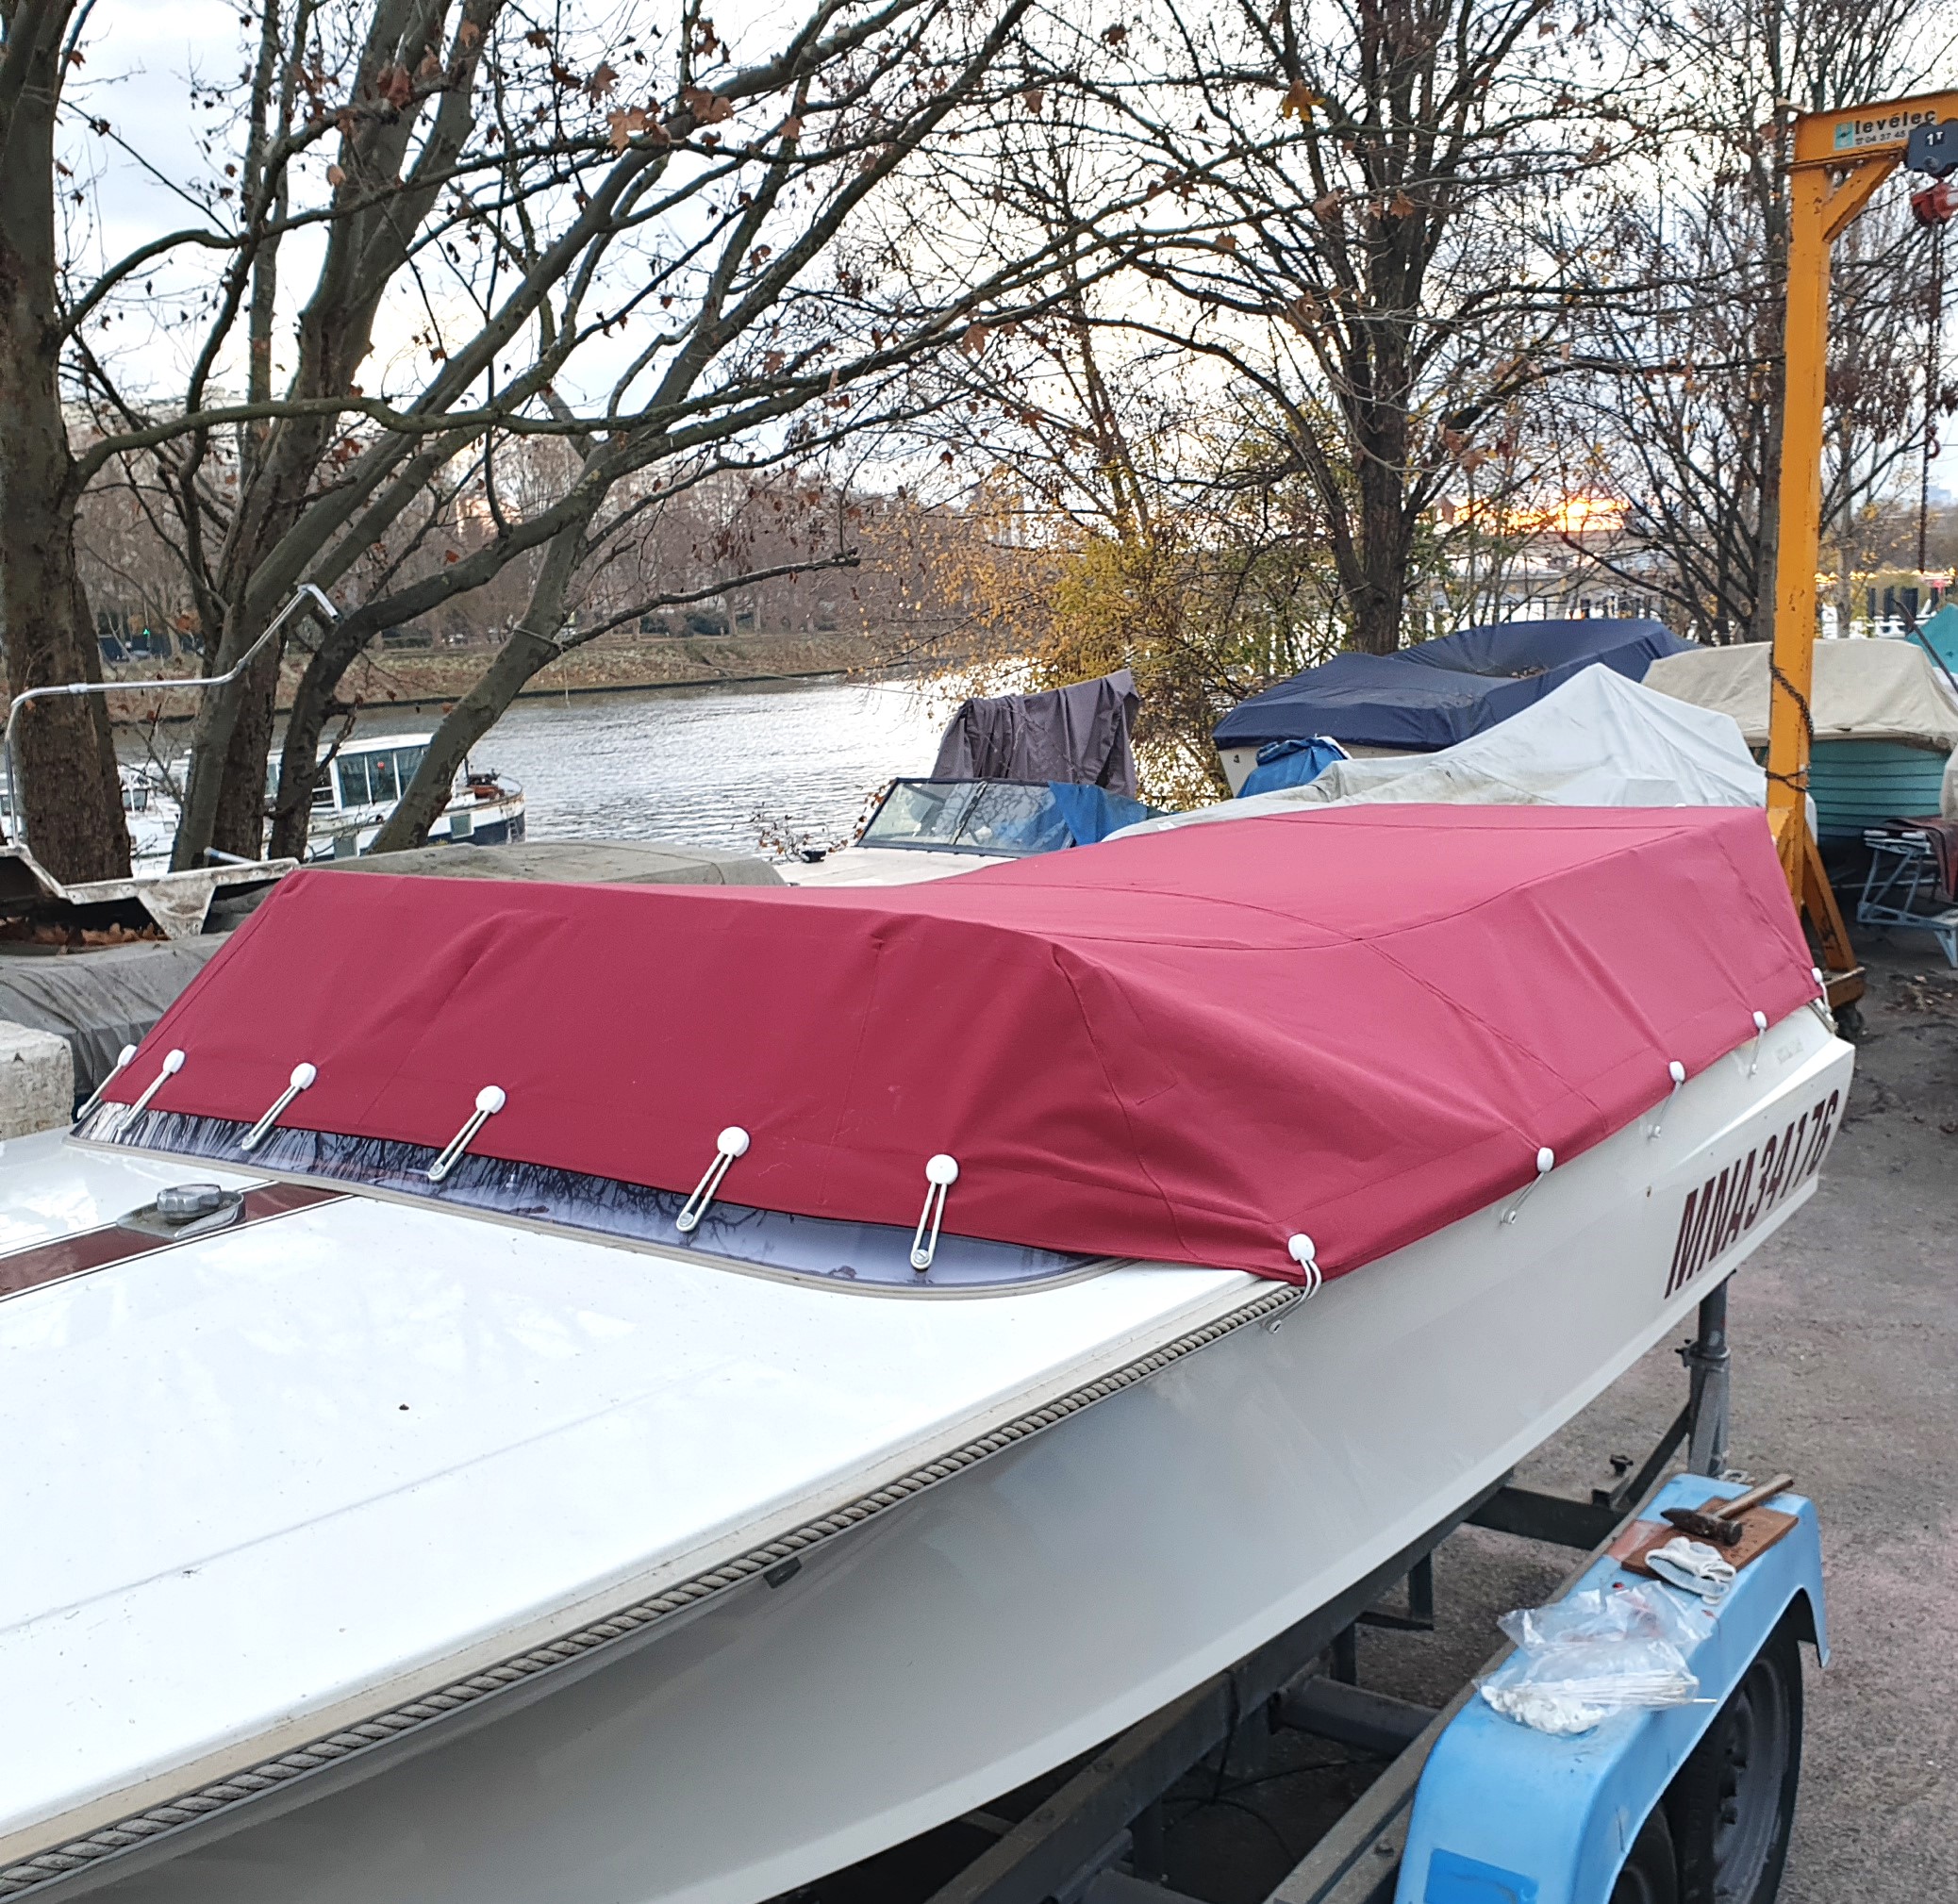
[0,808,1850,1904]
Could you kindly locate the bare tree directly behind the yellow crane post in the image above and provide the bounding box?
[1568,0,1952,642]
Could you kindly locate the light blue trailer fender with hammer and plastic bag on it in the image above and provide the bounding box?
[1394,1476,1827,1904]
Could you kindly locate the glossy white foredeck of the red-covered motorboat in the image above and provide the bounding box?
[0,1133,1253,1853]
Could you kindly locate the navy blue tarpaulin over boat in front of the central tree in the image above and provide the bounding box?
[1216,617,1692,753]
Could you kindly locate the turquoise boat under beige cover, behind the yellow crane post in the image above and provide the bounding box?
[1647,640,1958,839]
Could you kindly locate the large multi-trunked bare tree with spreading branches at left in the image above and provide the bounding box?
[15,0,1112,865]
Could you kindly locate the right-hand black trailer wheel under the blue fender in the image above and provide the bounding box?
[1667,1616,1801,1904]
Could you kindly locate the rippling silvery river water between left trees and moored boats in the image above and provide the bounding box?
[346,681,950,853]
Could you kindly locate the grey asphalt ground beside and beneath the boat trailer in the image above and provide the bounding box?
[805,935,1958,1904]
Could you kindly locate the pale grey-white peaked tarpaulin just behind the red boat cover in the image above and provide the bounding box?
[1126,663,1767,834]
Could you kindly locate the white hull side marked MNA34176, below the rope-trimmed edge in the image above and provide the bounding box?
[19,1012,1850,1904]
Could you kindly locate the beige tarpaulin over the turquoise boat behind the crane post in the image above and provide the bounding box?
[1645,640,1958,752]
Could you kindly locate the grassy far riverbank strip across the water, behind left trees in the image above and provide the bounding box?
[91,632,916,722]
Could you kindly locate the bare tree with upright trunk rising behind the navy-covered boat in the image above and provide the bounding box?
[1057,0,1649,652]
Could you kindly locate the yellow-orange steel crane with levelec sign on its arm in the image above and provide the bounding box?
[1768,92,1958,1006]
